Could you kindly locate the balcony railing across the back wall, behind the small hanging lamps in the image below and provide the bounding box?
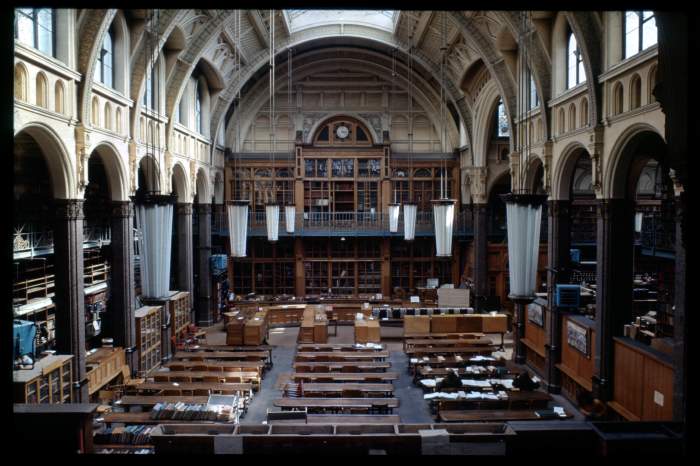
[213,209,473,237]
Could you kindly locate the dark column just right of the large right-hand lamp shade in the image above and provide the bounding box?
[545,200,571,393]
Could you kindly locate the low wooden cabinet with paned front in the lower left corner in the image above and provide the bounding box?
[12,355,73,403]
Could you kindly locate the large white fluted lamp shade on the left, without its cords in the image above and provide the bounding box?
[136,203,173,298]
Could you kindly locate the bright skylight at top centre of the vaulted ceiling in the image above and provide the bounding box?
[284,10,398,33]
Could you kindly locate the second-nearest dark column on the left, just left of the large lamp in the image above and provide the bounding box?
[110,201,138,374]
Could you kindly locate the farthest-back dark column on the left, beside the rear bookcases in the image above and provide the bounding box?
[195,204,213,327]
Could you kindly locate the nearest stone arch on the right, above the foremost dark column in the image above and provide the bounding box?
[603,123,666,199]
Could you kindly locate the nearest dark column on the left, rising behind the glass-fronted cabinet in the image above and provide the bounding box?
[53,199,88,403]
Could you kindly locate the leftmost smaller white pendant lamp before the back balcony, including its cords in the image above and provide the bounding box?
[226,10,249,257]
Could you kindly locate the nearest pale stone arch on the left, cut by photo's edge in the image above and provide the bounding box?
[14,123,77,199]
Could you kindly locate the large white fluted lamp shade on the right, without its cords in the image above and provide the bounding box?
[506,196,542,299]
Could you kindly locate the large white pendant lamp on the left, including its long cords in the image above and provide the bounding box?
[134,10,175,299]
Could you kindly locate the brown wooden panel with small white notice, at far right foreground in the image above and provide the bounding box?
[614,338,673,421]
